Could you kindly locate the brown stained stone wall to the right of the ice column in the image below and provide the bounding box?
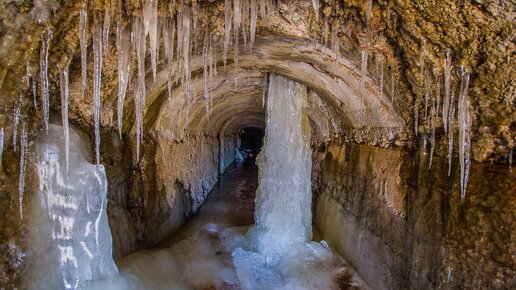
[313,141,516,289]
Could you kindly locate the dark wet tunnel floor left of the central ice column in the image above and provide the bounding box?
[115,160,258,289]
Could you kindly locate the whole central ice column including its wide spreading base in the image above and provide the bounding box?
[226,74,344,290]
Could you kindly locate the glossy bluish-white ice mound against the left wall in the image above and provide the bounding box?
[23,124,118,289]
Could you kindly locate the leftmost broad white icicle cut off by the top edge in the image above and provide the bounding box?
[143,0,159,81]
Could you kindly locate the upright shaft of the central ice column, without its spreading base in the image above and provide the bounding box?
[255,74,312,262]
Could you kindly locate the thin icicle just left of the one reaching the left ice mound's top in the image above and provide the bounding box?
[39,29,52,132]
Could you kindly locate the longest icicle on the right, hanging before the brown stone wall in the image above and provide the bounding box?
[458,68,471,198]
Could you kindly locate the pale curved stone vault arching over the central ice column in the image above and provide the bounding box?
[126,33,405,139]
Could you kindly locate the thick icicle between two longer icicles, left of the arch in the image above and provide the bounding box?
[116,13,131,139]
